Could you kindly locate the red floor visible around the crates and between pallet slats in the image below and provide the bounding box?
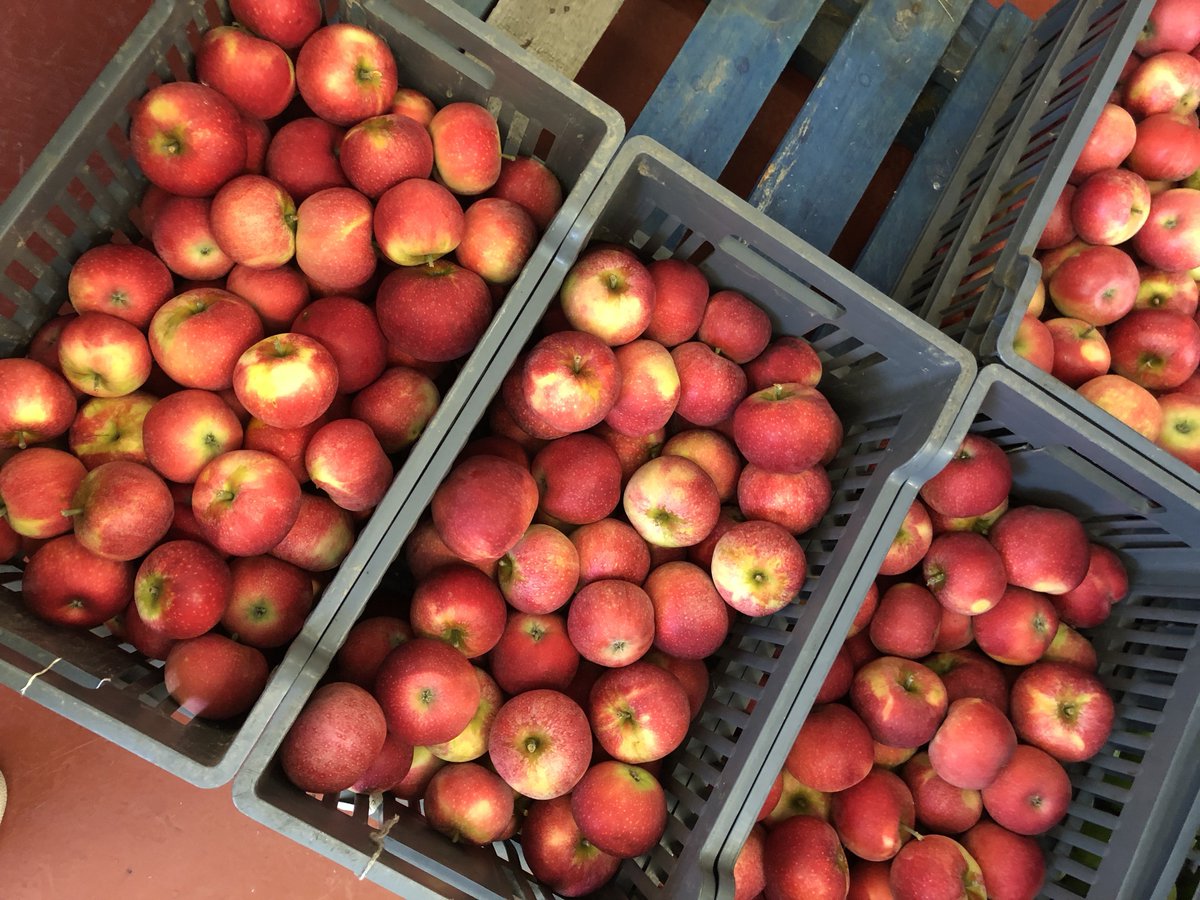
[0,0,1046,900]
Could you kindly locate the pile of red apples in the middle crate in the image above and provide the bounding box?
[280,236,842,896]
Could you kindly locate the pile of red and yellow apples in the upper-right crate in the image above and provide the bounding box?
[1014,0,1200,480]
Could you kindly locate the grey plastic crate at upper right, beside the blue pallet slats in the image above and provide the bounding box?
[894,0,1200,490]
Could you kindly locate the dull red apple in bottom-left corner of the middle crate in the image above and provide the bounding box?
[278,686,388,793]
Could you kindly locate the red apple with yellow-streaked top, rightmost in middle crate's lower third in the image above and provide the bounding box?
[588,662,690,763]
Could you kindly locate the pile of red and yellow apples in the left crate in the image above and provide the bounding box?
[0,0,562,719]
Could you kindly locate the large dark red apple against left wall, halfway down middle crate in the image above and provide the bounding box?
[431,456,538,562]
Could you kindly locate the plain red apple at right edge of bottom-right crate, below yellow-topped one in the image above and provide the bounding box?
[983,744,1070,835]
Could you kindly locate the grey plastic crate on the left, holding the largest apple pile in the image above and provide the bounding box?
[0,0,624,786]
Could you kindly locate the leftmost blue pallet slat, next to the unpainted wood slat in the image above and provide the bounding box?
[629,0,820,178]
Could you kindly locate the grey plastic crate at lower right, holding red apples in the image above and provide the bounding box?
[750,365,1200,900]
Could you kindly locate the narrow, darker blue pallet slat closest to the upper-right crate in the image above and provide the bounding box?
[854,4,1033,295]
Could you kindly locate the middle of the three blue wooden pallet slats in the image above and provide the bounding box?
[750,0,970,252]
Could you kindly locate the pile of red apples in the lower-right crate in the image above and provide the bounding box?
[733,434,1129,900]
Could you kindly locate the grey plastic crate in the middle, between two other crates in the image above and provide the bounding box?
[234,138,974,900]
